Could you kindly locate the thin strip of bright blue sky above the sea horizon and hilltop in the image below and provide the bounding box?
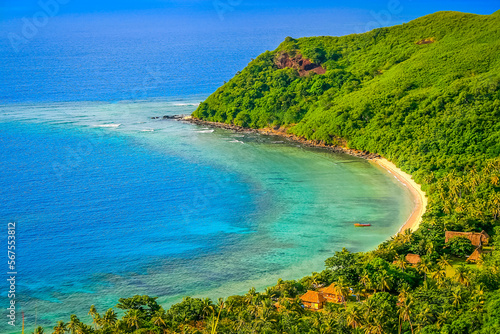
[0,0,500,19]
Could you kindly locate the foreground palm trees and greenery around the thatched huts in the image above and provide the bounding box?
[35,232,500,334]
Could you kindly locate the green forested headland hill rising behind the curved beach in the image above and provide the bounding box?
[193,11,500,235]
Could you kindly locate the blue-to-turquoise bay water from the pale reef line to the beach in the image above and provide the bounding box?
[0,99,412,332]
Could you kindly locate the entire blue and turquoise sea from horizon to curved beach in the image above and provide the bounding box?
[0,13,413,333]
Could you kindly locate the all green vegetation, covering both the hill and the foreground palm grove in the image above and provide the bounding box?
[36,12,500,334]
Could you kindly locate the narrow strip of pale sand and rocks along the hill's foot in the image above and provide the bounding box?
[180,116,427,233]
